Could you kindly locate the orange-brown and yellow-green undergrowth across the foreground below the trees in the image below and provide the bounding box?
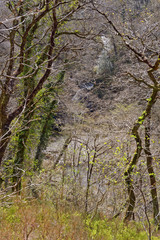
[0,194,160,240]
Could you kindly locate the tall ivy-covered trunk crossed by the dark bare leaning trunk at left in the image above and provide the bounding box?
[12,20,38,194]
